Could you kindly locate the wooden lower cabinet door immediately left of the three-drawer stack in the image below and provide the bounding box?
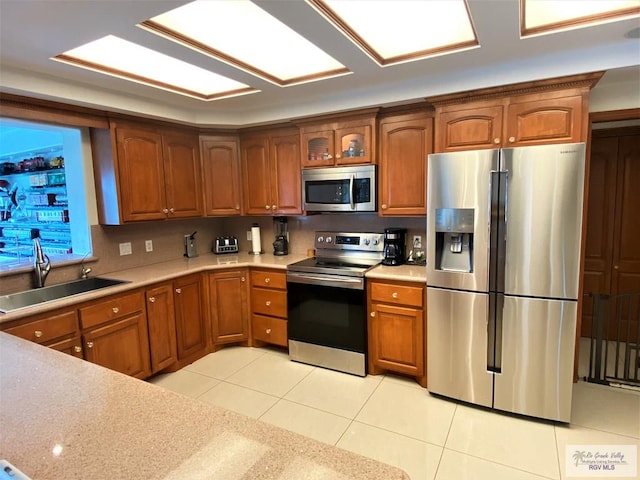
[209,268,249,350]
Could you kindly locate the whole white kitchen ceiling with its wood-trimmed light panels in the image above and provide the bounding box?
[0,0,640,126]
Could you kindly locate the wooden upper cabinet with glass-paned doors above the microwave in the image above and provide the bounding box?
[300,109,378,168]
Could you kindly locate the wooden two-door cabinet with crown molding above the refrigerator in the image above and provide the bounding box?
[427,72,603,152]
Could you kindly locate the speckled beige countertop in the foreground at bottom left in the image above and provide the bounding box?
[0,332,409,480]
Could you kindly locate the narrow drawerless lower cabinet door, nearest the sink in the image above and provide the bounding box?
[145,282,178,373]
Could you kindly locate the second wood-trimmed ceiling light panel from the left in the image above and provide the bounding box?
[140,0,348,85]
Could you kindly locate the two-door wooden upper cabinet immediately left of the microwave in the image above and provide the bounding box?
[240,129,302,215]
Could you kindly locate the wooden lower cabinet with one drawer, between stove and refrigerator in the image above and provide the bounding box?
[367,280,427,388]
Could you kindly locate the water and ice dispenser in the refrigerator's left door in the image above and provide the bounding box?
[435,208,474,273]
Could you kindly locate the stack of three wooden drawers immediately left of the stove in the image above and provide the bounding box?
[251,269,289,347]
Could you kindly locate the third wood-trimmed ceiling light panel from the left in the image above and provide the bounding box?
[307,0,478,65]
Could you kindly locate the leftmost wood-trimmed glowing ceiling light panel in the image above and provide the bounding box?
[53,35,256,100]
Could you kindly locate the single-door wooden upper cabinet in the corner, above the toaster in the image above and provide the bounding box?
[200,137,242,216]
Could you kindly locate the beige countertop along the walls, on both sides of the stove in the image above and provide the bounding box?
[0,253,426,323]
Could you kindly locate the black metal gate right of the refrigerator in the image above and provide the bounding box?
[584,293,640,387]
